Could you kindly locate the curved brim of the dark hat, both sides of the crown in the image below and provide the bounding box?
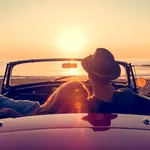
[81,55,121,80]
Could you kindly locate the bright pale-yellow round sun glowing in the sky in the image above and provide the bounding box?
[58,29,86,52]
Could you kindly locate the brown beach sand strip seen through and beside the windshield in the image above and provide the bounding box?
[0,77,150,97]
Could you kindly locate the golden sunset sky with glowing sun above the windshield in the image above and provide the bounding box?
[0,0,150,60]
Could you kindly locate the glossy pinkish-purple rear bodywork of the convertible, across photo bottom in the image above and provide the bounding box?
[0,114,150,150]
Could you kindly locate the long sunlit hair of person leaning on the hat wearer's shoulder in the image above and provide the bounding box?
[34,81,90,115]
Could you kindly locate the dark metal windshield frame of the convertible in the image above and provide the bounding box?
[1,58,138,94]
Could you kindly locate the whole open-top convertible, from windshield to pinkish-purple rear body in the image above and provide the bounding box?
[0,58,150,150]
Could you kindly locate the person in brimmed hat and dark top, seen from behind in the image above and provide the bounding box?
[81,48,134,113]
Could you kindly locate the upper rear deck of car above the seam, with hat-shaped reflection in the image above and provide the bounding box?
[0,113,150,133]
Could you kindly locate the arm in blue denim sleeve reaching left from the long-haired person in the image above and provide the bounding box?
[0,95,40,115]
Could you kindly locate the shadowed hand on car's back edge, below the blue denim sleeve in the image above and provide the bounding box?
[0,108,23,119]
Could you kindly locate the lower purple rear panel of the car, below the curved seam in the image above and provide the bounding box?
[0,128,150,150]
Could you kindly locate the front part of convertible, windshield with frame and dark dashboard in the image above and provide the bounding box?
[1,58,142,104]
